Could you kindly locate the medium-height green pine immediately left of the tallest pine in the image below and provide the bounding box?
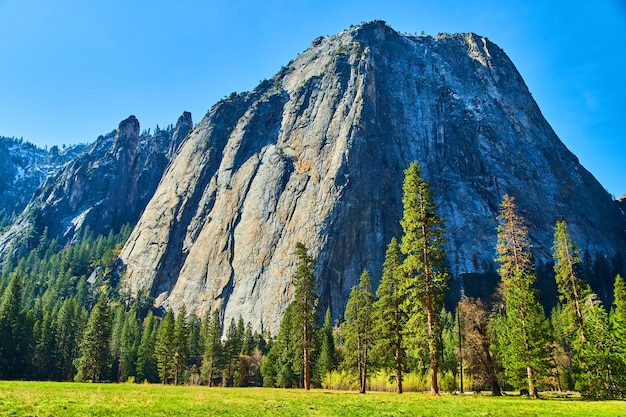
[374,238,407,394]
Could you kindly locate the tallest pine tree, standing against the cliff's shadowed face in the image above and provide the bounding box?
[400,162,448,395]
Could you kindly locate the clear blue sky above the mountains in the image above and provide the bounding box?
[0,0,626,196]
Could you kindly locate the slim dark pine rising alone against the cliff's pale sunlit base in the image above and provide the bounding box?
[291,242,318,390]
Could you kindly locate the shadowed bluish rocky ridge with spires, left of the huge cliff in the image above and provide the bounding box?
[0,112,193,256]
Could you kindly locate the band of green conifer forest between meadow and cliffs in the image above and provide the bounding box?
[0,163,626,398]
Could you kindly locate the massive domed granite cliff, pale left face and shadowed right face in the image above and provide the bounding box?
[120,21,626,332]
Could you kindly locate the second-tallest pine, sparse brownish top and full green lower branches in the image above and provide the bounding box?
[496,195,548,398]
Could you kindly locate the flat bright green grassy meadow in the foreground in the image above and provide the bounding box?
[0,381,626,417]
